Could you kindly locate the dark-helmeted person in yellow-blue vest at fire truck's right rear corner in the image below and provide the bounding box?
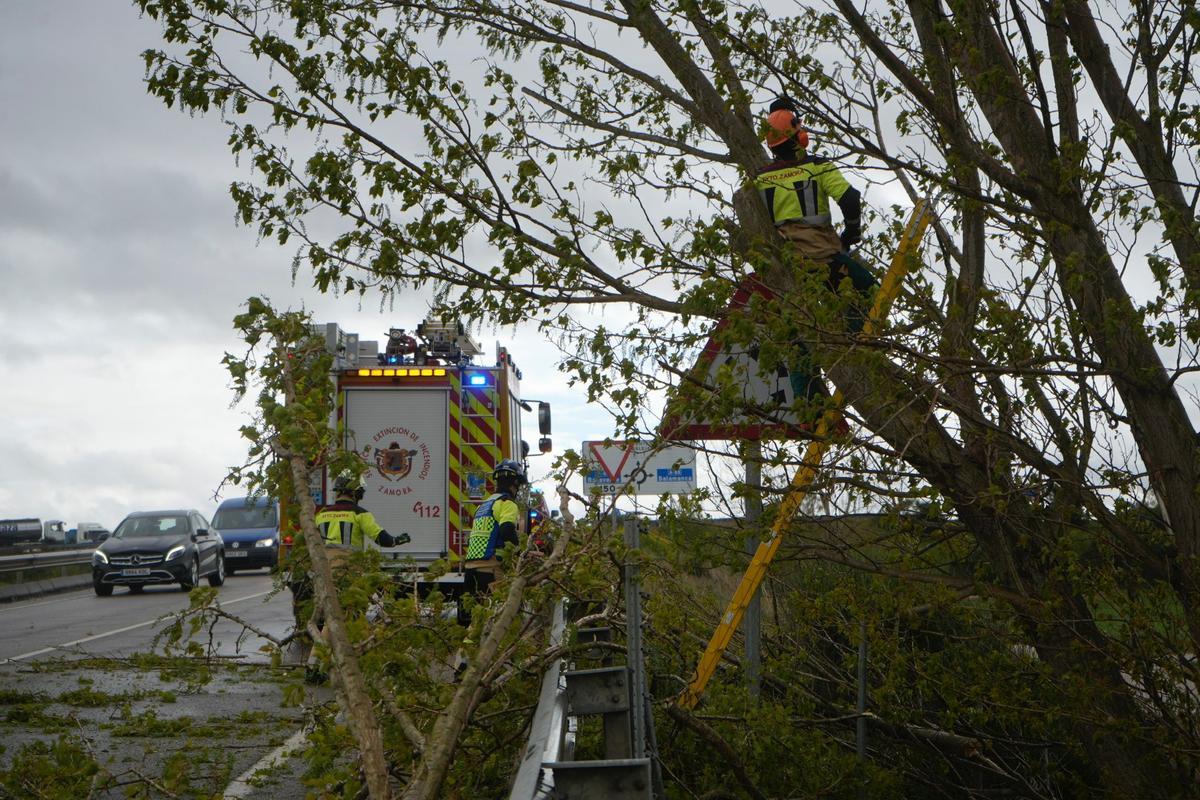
[458,459,526,625]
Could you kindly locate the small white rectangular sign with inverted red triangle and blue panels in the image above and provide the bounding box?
[583,441,696,494]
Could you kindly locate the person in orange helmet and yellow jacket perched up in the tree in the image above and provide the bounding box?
[755,96,876,399]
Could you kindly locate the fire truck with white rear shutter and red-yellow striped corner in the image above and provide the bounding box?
[290,318,551,567]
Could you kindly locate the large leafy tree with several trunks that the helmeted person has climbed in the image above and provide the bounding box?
[136,0,1200,796]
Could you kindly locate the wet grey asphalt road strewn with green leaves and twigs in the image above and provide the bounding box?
[0,571,329,799]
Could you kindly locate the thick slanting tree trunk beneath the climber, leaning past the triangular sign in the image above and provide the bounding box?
[734,175,1176,798]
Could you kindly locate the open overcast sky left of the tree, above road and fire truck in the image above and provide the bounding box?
[0,0,611,527]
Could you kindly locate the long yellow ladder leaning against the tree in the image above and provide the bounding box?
[679,199,932,709]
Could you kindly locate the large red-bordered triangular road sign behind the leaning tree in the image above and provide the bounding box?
[661,275,806,440]
